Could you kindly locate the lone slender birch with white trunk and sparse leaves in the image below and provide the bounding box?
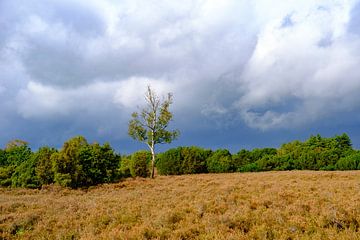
[128,86,179,178]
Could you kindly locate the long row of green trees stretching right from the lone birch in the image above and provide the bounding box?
[156,134,360,175]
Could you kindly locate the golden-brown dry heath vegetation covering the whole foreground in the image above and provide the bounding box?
[0,171,360,239]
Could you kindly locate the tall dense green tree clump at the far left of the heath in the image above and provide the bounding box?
[0,136,121,188]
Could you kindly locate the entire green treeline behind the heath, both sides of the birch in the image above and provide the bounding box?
[0,134,360,188]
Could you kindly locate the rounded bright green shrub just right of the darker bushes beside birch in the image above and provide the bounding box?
[206,149,235,173]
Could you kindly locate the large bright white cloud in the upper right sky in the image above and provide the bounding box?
[236,2,360,129]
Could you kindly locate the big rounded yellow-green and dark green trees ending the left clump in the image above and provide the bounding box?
[51,136,120,187]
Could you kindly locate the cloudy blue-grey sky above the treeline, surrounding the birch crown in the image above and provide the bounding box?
[0,0,360,153]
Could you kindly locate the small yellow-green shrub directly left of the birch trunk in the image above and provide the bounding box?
[130,151,151,177]
